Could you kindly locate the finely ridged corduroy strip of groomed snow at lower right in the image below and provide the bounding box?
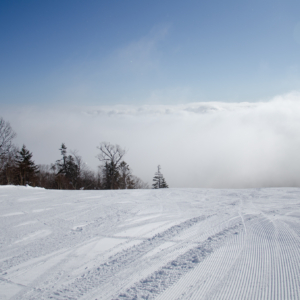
[207,211,300,300]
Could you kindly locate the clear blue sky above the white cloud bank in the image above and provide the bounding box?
[0,0,300,105]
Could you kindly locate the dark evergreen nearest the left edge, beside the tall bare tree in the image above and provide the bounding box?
[16,145,39,185]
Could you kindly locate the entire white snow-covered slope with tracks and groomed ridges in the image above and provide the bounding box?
[0,186,300,300]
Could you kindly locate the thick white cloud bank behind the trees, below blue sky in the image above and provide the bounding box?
[2,93,300,188]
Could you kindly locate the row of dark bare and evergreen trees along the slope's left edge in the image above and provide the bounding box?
[0,117,154,190]
